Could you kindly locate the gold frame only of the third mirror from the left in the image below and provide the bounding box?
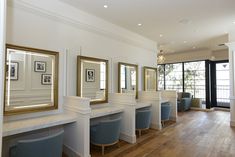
[118,62,139,99]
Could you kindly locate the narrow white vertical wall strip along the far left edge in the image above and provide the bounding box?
[0,0,6,157]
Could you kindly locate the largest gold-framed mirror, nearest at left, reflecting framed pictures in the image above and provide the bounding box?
[4,44,59,115]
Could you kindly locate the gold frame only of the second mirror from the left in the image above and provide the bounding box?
[77,56,109,105]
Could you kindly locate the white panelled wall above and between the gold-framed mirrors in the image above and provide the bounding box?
[4,0,156,119]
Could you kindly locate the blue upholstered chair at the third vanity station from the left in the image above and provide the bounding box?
[135,109,151,136]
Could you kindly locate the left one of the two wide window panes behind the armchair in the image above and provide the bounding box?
[165,63,183,92]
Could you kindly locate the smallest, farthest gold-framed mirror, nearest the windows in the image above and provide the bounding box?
[143,66,157,91]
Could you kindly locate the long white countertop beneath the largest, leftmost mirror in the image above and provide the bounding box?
[3,113,77,137]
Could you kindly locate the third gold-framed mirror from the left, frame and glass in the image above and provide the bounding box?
[118,62,138,99]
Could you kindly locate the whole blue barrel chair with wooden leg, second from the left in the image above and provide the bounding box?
[90,117,121,155]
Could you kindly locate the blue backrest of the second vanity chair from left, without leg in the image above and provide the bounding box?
[96,117,122,144]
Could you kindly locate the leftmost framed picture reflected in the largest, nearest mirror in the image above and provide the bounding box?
[6,62,19,81]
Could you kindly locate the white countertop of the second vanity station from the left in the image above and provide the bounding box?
[90,105,124,118]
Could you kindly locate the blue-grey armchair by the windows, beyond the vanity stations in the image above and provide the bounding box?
[177,92,192,111]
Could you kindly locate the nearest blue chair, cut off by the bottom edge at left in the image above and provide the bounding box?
[10,131,64,157]
